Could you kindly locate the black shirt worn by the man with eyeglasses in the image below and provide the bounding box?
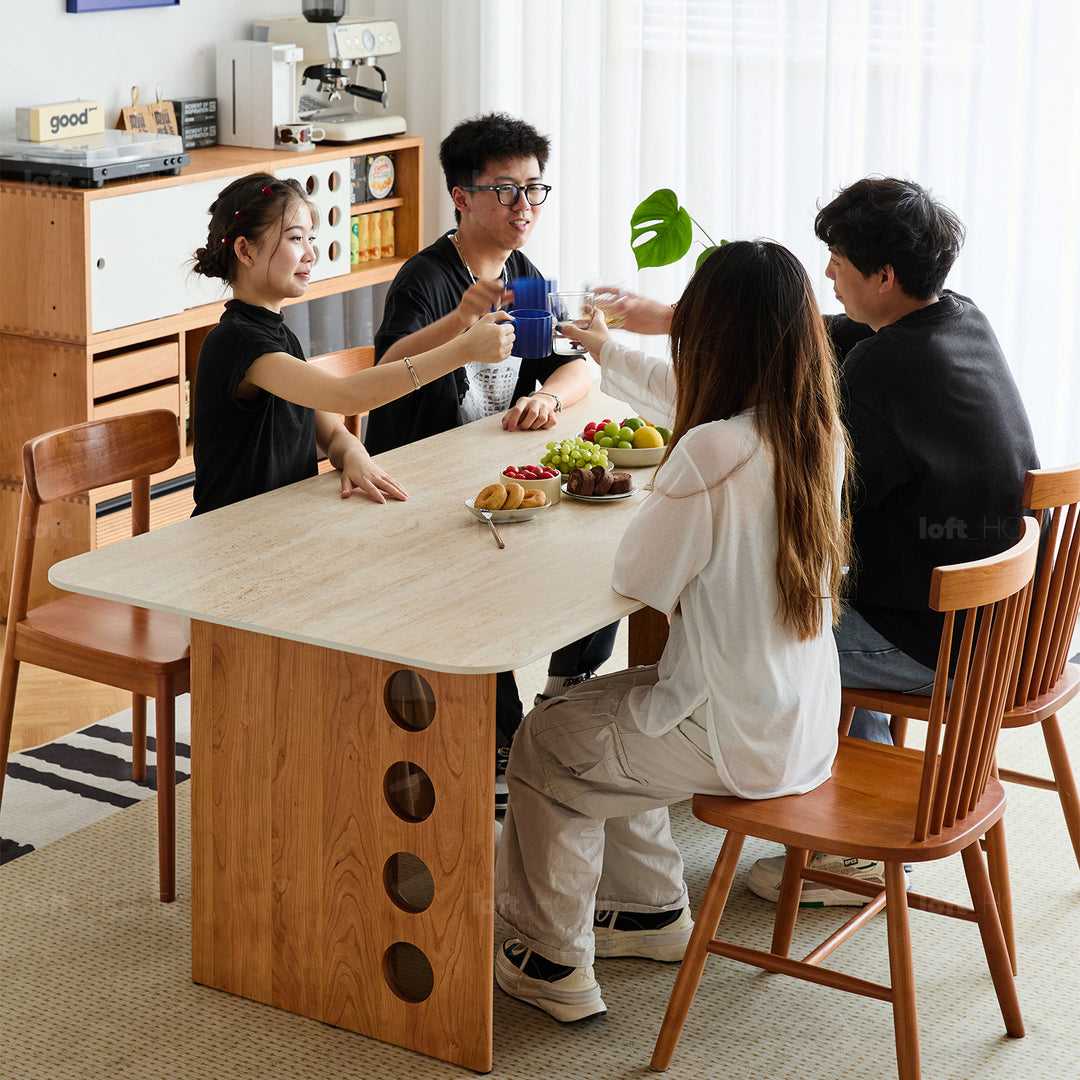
[364,233,572,454]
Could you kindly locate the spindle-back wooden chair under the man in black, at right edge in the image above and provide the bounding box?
[843,464,1080,973]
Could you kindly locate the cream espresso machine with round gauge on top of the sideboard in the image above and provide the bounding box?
[255,16,405,143]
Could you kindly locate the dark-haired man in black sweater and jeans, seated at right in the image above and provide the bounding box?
[748,177,1039,905]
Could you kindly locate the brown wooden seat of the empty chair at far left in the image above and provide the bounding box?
[16,595,191,678]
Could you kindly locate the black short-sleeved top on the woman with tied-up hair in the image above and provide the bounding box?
[192,300,319,516]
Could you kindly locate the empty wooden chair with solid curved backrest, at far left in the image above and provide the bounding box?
[0,409,190,901]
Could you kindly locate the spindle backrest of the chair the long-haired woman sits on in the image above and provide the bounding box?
[914,517,1039,841]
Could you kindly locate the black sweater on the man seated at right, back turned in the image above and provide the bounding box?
[827,292,1039,667]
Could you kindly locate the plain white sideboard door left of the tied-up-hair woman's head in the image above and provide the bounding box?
[90,179,227,334]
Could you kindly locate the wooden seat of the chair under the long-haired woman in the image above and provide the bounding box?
[693,734,1005,862]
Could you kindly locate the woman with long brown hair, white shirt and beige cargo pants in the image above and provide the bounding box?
[496,241,848,1022]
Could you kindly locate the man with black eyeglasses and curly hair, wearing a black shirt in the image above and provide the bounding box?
[365,112,617,806]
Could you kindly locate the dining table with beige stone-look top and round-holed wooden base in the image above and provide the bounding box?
[50,387,667,1072]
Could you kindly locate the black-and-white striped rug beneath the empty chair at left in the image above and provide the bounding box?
[0,694,191,863]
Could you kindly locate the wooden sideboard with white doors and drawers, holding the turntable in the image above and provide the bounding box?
[0,136,423,613]
